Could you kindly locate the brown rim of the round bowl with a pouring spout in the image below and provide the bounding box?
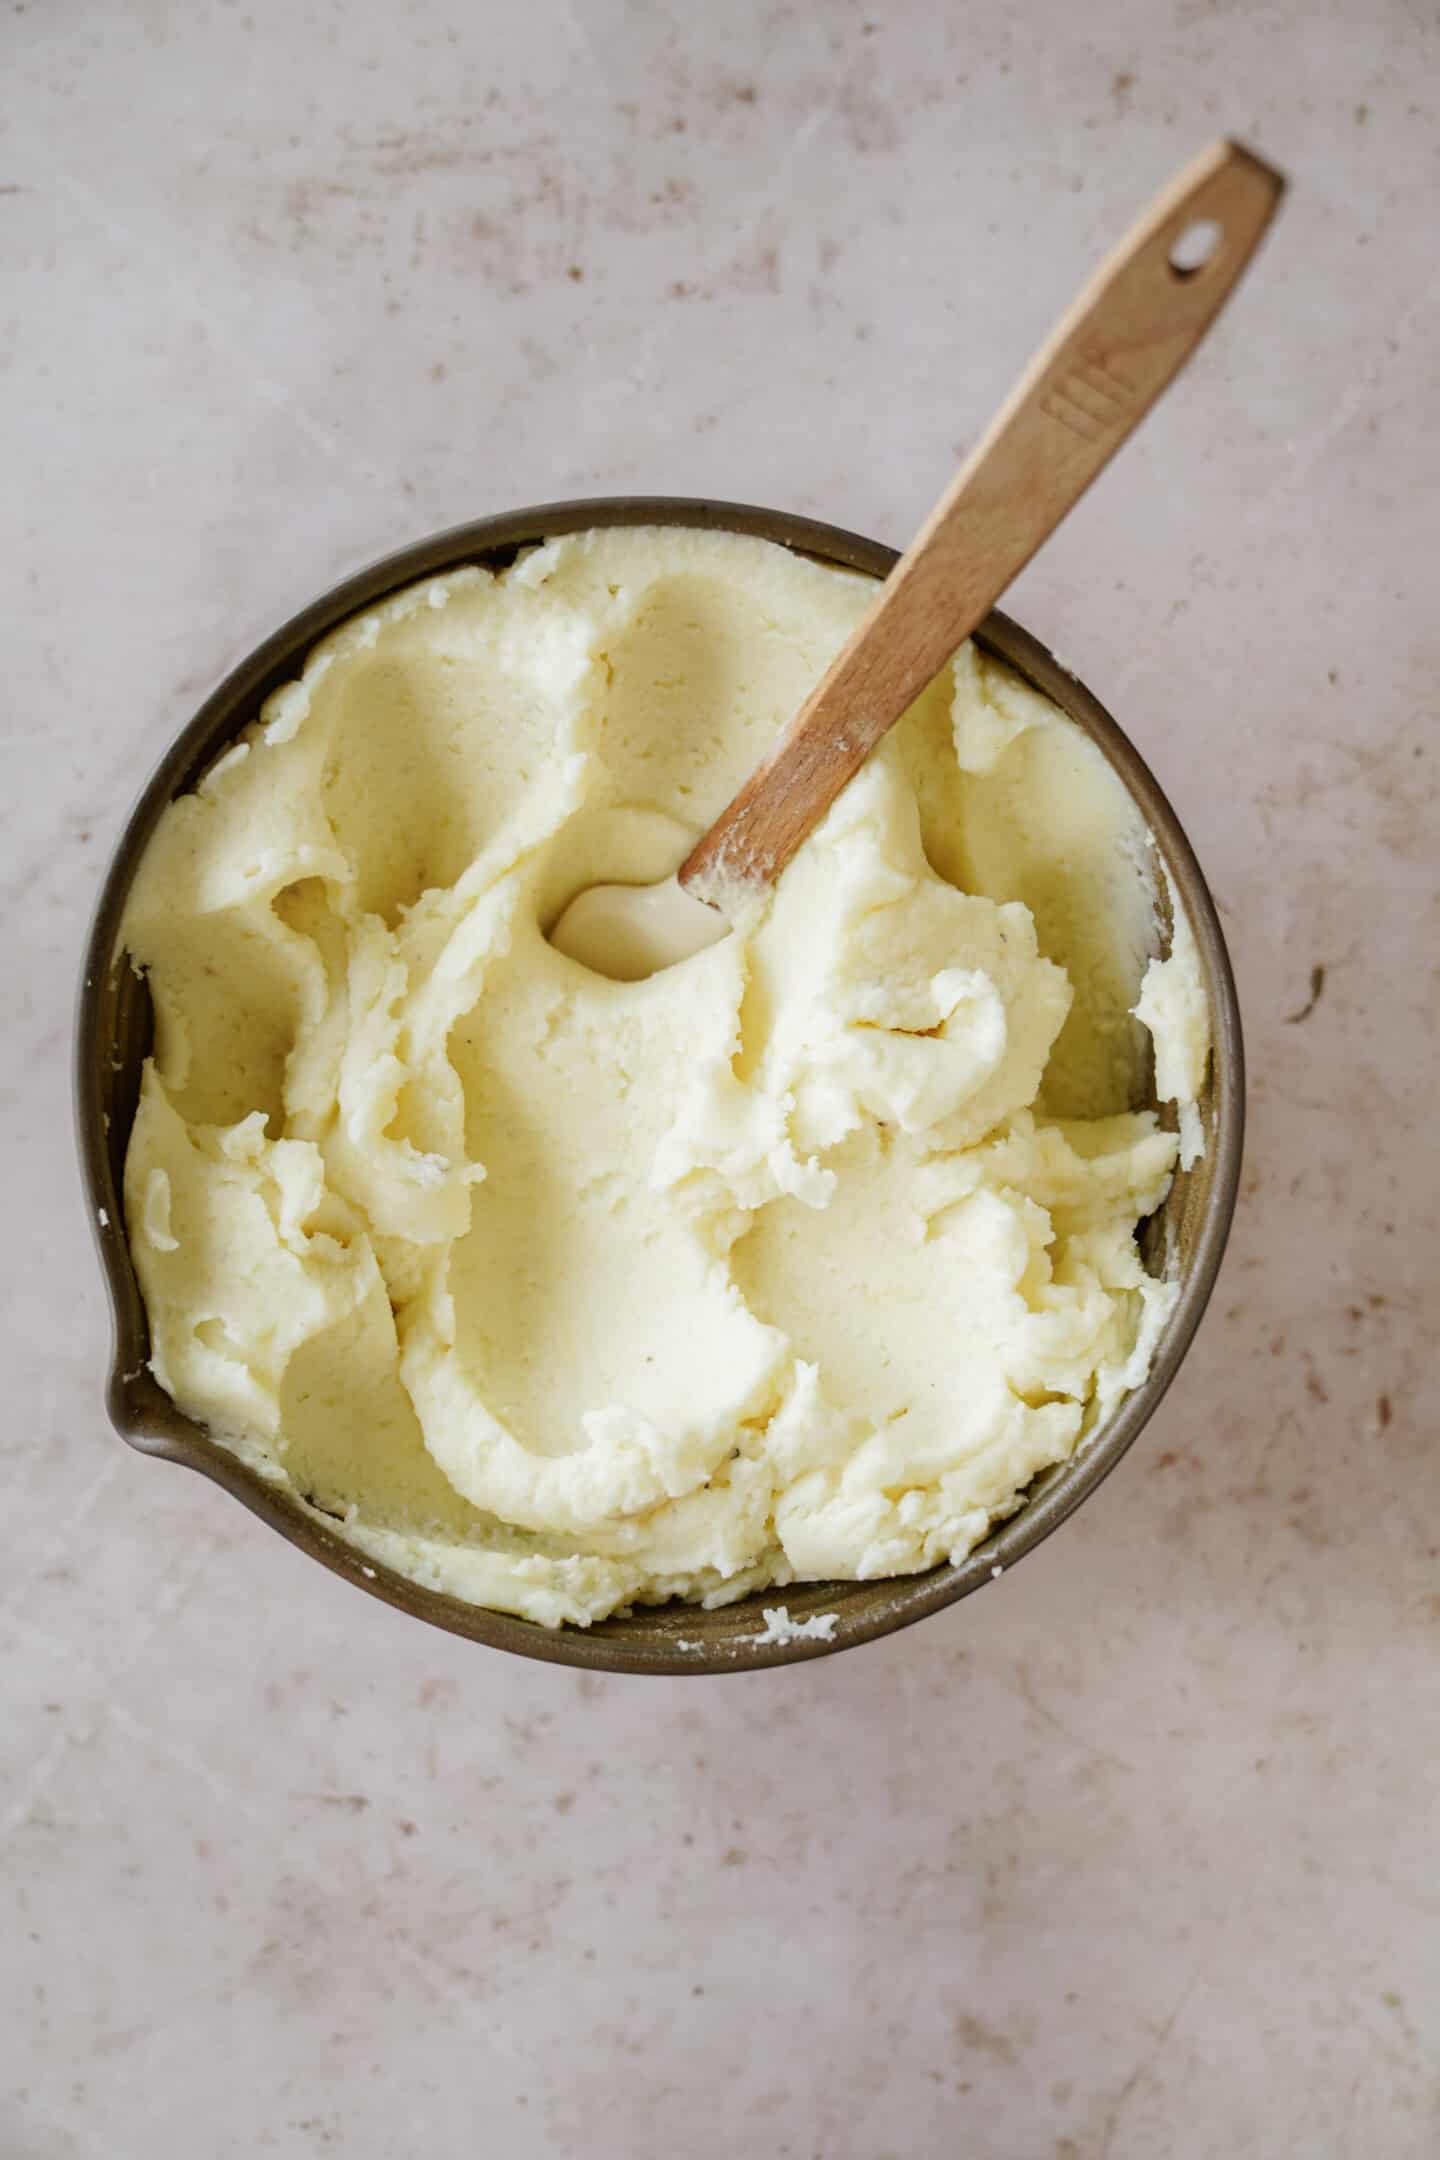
[73,495,1246,1676]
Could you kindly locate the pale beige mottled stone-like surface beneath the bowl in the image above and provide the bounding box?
[0,0,1440,2160]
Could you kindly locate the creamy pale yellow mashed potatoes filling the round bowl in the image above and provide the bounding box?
[125,529,1209,1624]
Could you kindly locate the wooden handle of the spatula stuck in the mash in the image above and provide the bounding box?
[680,143,1285,912]
